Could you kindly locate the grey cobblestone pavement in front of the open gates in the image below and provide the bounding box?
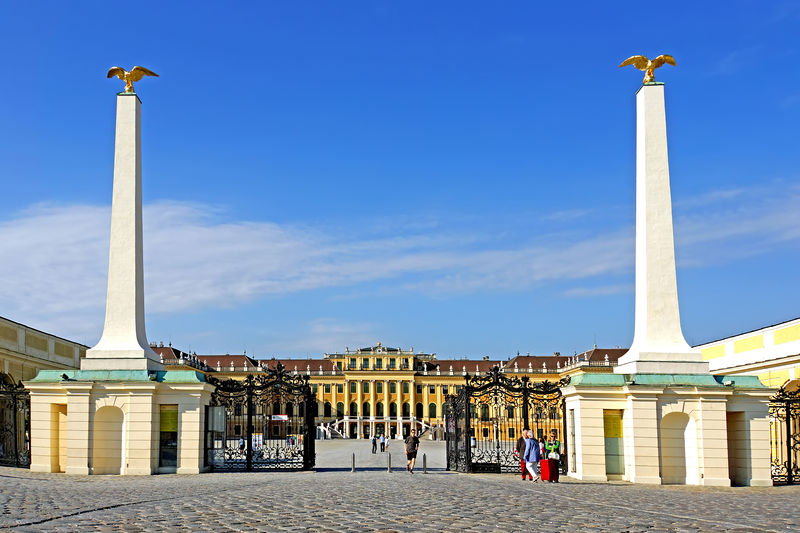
[0,442,800,533]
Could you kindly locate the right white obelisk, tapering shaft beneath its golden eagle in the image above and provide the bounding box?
[614,82,708,374]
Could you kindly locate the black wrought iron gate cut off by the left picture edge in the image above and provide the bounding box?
[0,374,31,468]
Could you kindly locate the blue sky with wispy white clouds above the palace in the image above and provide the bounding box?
[0,1,800,357]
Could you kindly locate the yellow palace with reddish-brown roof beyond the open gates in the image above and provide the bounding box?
[153,342,625,440]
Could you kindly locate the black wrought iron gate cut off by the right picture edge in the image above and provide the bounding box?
[769,382,800,484]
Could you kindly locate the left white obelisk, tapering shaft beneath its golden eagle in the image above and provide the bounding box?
[81,92,163,370]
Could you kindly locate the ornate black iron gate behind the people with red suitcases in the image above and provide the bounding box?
[445,367,569,473]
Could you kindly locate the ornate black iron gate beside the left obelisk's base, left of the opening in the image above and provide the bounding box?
[206,364,317,470]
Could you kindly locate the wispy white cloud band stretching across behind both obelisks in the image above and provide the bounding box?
[0,184,800,340]
